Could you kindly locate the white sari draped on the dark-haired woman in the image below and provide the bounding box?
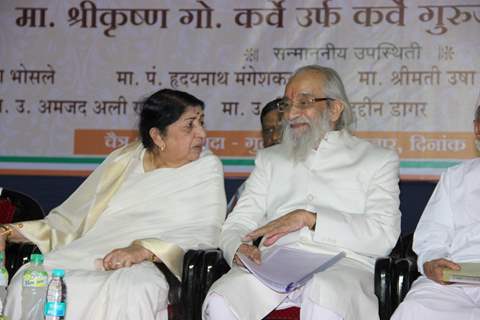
[6,148,225,320]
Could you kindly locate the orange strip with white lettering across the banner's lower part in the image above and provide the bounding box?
[74,129,476,159]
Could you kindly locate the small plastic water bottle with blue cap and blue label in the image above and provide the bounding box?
[44,269,67,320]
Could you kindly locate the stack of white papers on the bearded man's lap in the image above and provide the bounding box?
[239,246,345,293]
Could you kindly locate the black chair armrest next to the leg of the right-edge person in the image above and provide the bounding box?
[392,257,420,311]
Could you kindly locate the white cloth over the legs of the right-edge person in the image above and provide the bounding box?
[392,276,480,320]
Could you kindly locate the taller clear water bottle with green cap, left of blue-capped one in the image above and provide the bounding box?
[22,253,48,320]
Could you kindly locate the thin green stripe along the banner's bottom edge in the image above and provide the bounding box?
[0,156,459,169]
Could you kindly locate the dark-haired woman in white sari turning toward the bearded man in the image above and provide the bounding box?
[0,89,226,320]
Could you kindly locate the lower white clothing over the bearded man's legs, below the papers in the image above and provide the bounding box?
[203,259,378,320]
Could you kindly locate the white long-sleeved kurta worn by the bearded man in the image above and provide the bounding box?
[210,131,400,320]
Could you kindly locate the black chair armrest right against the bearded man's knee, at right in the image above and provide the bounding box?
[374,257,393,320]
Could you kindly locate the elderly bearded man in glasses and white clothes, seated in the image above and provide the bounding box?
[203,65,400,320]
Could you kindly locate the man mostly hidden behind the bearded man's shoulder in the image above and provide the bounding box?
[227,98,282,215]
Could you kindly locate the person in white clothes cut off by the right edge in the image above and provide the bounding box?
[392,105,480,320]
